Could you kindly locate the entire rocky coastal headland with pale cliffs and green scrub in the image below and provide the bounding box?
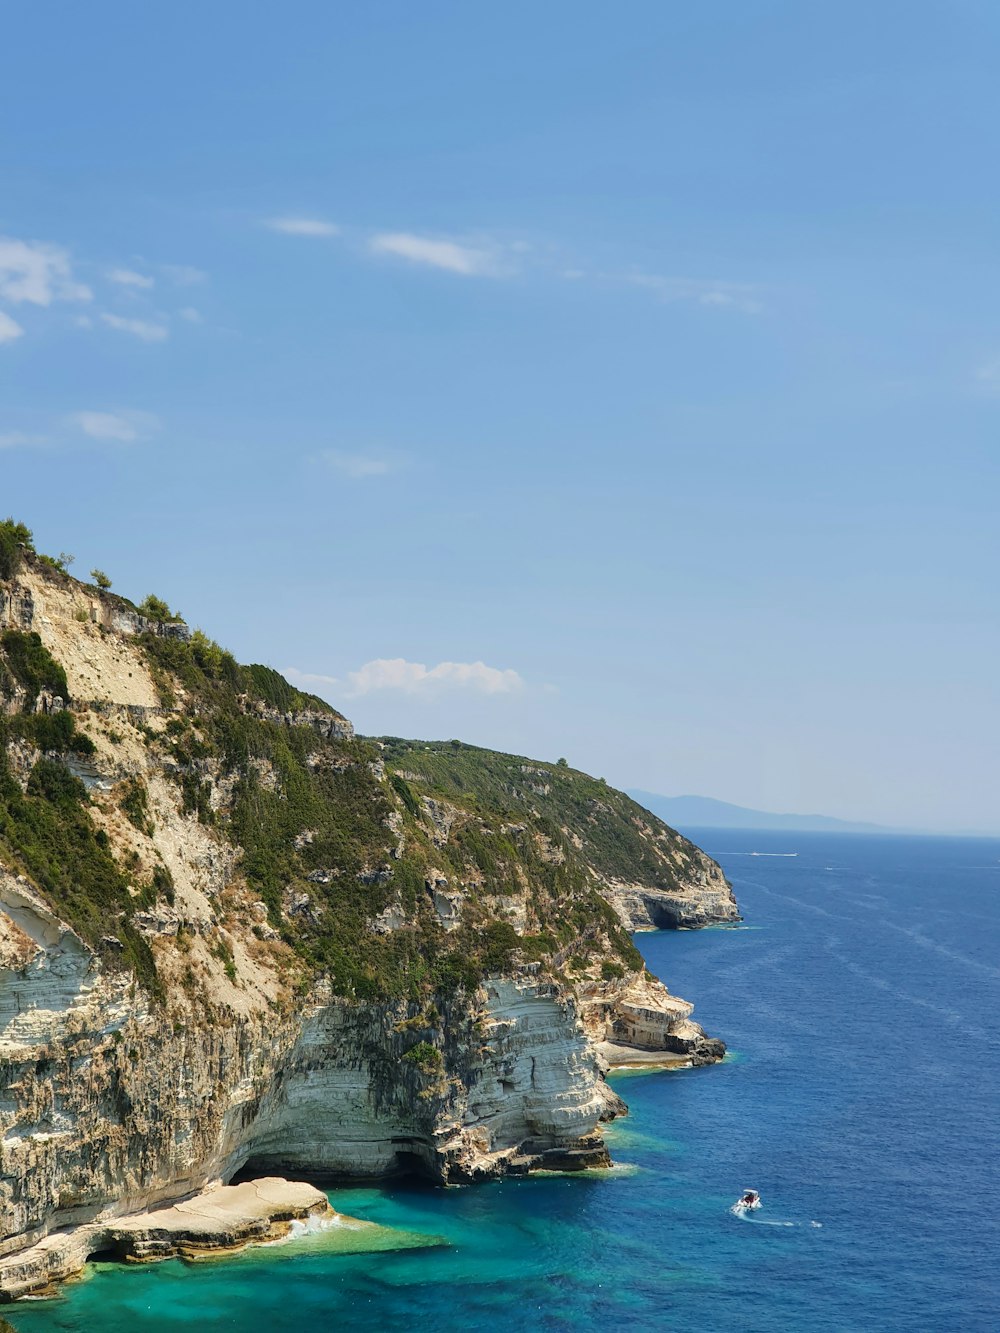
[0,525,737,1296]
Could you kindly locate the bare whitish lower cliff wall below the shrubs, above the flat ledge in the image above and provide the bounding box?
[0,874,618,1288]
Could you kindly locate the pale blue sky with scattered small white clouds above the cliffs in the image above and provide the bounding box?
[0,0,1000,832]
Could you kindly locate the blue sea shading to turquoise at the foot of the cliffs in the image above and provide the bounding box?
[9,829,1000,1333]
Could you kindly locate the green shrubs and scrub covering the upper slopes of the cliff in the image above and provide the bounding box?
[0,525,730,1004]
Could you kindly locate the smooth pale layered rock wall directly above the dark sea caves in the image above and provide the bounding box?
[247,978,604,1180]
